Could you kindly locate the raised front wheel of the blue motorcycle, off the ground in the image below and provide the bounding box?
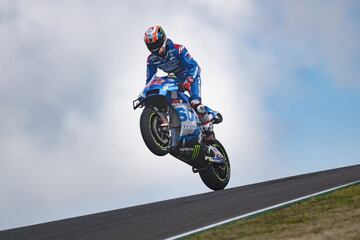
[140,108,170,156]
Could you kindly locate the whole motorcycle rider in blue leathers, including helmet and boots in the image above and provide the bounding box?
[144,26,215,141]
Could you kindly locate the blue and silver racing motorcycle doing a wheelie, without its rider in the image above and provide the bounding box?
[133,75,230,190]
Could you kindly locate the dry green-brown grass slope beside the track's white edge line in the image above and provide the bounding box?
[186,184,360,240]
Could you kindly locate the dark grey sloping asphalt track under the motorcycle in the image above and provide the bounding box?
[0,164,360,240]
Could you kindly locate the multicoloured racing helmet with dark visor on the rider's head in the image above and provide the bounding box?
[144,26,167,55]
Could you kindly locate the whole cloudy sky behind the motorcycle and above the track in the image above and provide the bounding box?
[0,0,360,230]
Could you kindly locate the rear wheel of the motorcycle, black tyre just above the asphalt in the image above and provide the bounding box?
[199,140,231,191]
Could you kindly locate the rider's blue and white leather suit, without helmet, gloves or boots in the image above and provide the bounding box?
[146,39,201,102]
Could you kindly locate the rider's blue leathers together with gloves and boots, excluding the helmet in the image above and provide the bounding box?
[146,38,214,138]
